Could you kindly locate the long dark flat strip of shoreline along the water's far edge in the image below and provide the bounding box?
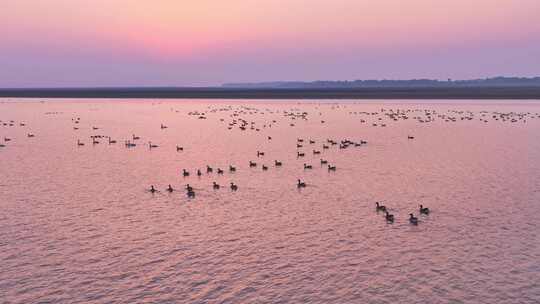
[0,86,540,100]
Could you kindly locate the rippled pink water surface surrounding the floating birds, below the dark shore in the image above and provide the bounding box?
[0,99,540,303]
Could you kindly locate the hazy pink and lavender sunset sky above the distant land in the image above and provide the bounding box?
[0,0,540,87]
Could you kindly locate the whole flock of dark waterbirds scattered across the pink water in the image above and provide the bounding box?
[0,104,540,225]
